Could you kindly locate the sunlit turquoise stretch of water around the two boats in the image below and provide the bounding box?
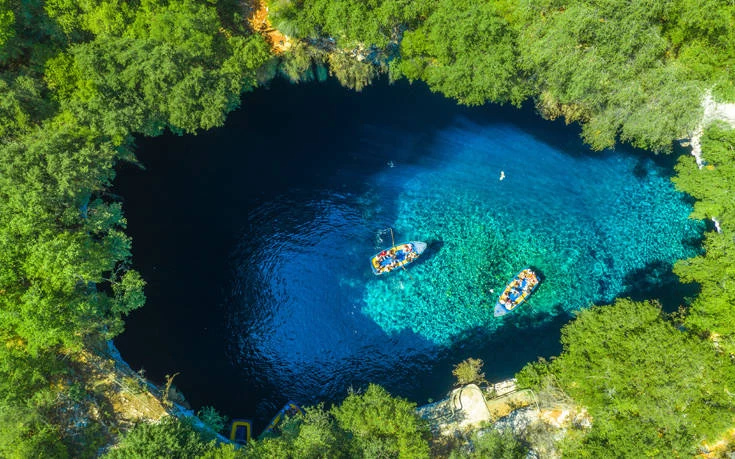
[361,118,701,345]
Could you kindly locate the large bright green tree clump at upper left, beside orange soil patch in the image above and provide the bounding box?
[47,0,269,139]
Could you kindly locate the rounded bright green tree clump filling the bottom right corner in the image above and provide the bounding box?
[525,300,735,457]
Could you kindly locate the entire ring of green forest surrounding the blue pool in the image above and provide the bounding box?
[0,0,735,457]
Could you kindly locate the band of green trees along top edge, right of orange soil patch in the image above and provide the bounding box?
[278,0,735,152]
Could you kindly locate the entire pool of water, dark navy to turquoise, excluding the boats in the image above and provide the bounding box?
[116,78,702,432]
